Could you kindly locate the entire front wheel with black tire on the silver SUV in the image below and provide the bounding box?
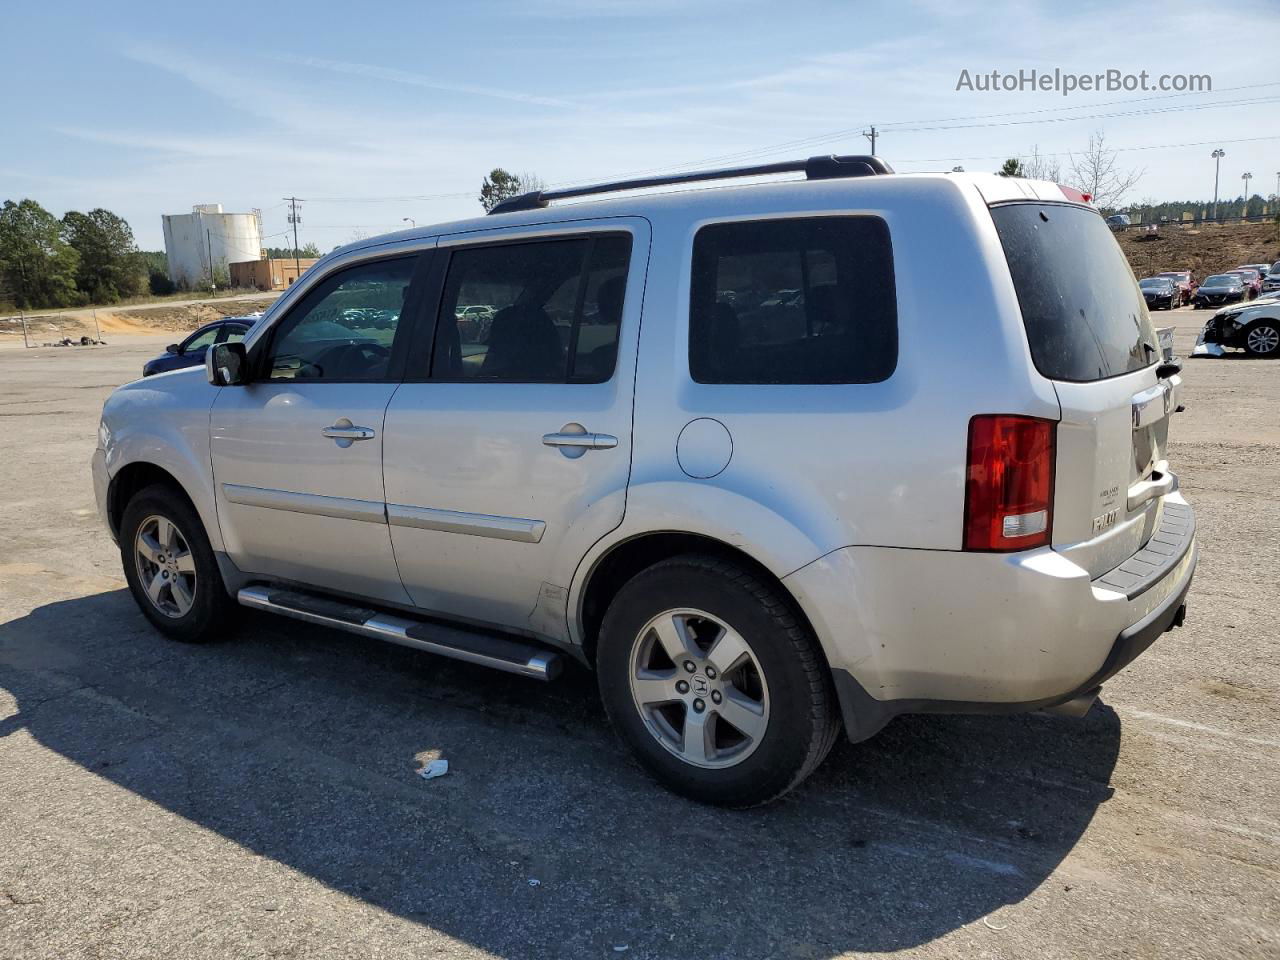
[120,484,237,643]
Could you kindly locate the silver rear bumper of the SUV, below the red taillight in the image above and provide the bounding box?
[785,493,1198,740]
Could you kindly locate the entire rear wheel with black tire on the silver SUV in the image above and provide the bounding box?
[596,556,840,808]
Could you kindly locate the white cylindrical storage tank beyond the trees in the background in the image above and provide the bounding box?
[160,204,262,289]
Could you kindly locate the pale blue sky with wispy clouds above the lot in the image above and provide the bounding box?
[0,0,1280,250]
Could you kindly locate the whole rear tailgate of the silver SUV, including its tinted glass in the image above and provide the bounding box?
[991,201,1180,577]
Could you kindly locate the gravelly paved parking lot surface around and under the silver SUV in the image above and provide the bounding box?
[0,320,1280,960]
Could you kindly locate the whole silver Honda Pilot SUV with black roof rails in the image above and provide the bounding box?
[93,157,1197,805]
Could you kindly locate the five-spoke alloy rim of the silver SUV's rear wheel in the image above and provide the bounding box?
[631,608,769,768]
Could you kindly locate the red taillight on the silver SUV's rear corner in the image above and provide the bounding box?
[964,413,1057,550]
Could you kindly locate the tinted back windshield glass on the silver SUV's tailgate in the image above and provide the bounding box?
[991,204,1160,383]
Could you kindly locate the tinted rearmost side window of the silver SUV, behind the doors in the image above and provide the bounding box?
[689,216,897,384]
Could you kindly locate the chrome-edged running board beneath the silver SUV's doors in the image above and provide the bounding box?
[236,585,563,680]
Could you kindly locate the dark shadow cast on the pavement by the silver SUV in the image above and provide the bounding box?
[0,590,1120,957]
